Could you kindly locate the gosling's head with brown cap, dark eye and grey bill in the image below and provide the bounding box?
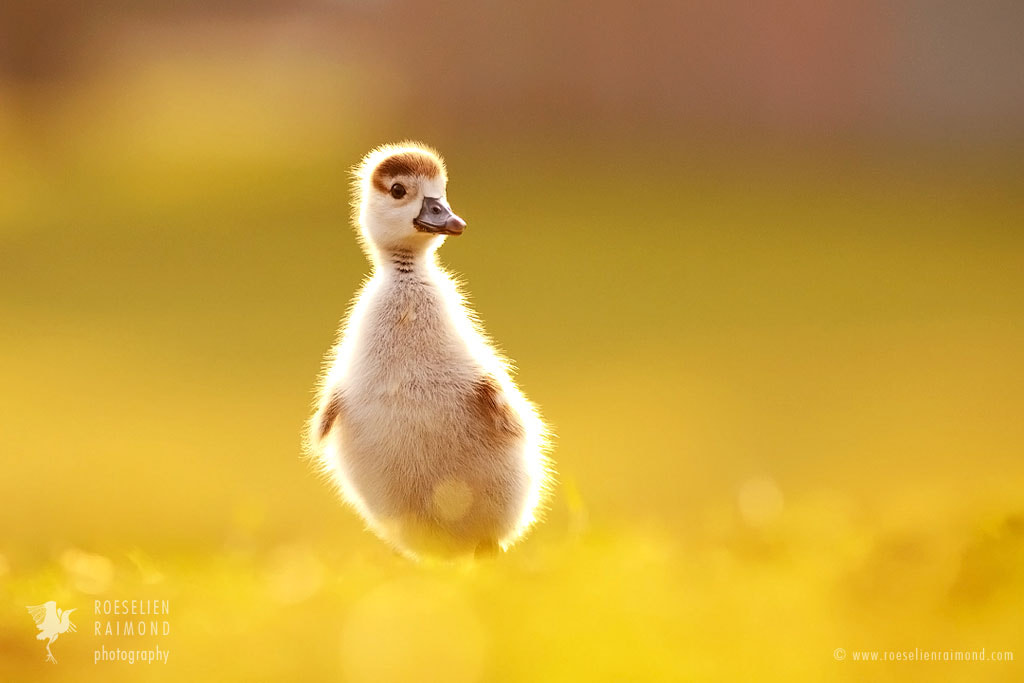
[354,142,466,251]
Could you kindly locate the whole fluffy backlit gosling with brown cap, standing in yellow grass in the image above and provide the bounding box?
[310,144,549,557]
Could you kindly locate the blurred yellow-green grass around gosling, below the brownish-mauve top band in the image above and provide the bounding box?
[0,54,1024,681]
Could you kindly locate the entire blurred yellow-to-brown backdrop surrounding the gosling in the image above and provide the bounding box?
[0,0,1024,682]
